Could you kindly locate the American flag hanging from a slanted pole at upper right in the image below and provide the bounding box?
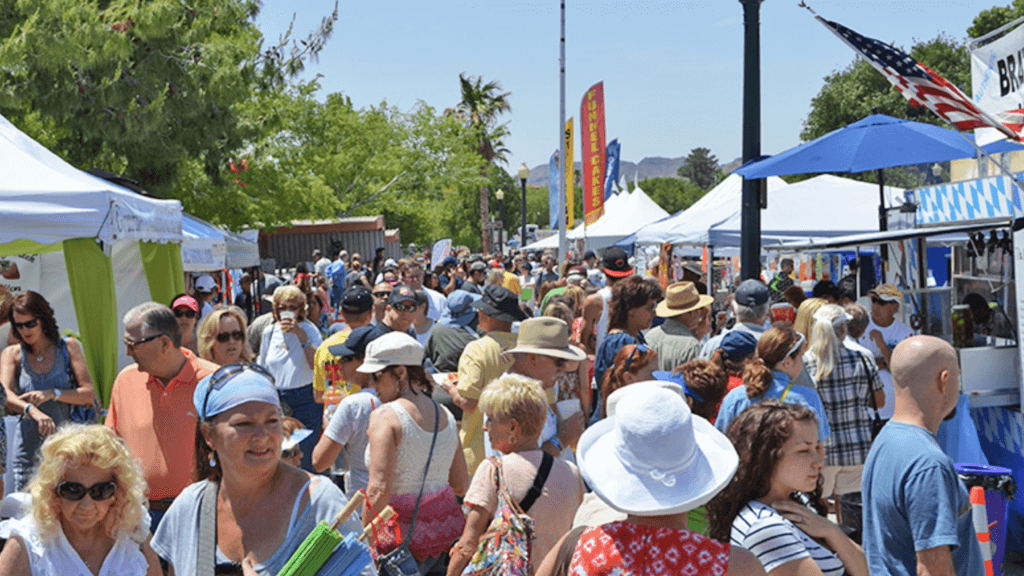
[808,8,1022,139]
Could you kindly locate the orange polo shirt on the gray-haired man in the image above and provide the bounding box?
[104,348,219,500]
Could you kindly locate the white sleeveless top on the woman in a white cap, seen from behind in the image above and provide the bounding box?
[366,402,459,496]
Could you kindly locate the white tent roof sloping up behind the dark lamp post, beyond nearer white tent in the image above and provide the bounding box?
[634,174,786,246]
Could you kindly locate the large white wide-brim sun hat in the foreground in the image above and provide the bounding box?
[577,382,739,517]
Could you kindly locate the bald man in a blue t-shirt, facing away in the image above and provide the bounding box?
[862,336,985,576]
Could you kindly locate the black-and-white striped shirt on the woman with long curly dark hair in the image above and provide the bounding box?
[730,500,845,576]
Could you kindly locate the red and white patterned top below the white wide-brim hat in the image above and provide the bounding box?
[569,522,729,576]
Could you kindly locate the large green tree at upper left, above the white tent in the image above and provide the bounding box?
[0,0,337,200]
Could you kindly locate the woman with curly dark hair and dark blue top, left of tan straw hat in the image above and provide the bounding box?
[590,276,664,423]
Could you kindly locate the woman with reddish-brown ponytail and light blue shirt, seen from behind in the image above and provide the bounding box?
[715,322,831,441]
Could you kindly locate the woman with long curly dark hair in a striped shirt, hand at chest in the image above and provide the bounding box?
[708,401,868,576]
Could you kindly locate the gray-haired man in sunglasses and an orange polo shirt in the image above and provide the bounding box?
[104,302,218,531]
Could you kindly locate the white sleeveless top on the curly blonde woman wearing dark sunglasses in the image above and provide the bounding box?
[11,516,150,576]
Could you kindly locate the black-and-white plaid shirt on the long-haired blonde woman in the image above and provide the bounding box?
[804,346,891,466]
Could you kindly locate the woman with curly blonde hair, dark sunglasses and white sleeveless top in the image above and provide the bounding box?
[0,424,162,576]
